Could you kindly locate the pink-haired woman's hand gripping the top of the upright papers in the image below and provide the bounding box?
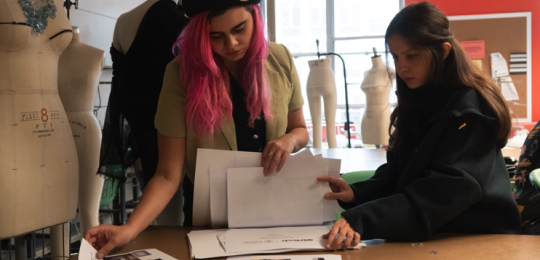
[261,134,295,176]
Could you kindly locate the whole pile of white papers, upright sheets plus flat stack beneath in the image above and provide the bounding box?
[188,149,352,258]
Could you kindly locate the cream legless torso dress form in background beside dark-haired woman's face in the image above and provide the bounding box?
[360,55,395,145]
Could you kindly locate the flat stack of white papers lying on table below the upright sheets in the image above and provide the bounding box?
[188,225,365,259]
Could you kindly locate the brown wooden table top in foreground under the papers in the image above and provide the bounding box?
[106,226,540,260]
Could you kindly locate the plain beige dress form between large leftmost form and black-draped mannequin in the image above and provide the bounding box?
[58,27,104,234]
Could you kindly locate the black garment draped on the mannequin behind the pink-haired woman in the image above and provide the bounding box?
[100,0,187,174]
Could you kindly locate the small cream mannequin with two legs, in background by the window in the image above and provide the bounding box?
[306,59,337,148]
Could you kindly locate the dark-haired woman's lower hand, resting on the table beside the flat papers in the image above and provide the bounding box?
[323,218,360,250]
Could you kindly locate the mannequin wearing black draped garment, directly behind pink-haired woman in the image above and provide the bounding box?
[108,0,186,225]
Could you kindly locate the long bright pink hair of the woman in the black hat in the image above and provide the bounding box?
[174,5,273,138]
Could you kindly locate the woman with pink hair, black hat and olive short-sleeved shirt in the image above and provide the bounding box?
[84,0,308,258]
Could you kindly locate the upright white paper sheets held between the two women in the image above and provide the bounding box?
[193,149,341,228]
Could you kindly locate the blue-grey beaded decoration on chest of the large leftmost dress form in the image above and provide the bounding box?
[19,0,56,34]
